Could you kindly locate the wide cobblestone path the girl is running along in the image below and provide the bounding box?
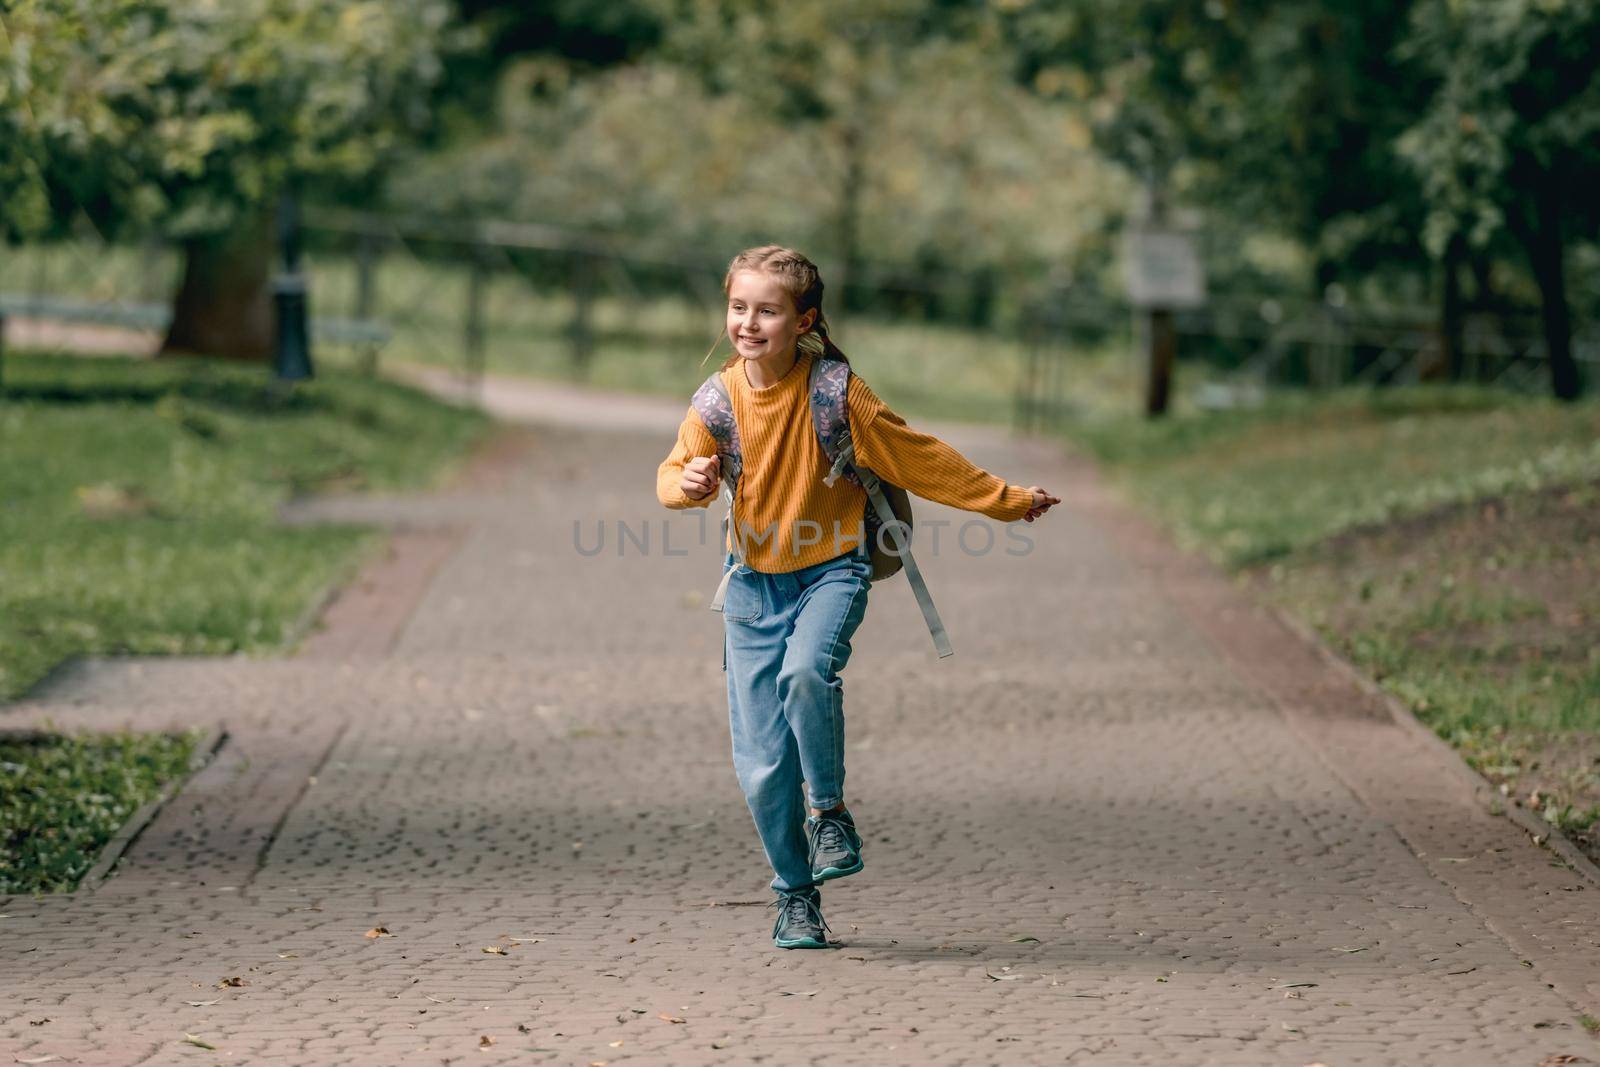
[0,385,1600,1067]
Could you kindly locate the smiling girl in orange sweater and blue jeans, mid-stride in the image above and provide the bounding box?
[656,245,1061,949]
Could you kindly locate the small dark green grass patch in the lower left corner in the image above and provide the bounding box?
[0,733,197,893]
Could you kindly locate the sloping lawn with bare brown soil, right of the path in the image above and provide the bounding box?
[1074,387,1600,857]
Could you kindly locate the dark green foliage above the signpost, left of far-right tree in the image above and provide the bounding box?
[998,0,1424,291]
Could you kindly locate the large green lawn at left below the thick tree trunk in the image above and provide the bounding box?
[0,354,485,699]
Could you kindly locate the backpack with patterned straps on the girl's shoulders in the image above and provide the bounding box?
[691,357,954,659]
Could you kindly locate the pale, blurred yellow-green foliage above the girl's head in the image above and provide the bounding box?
[392,0,1126,294]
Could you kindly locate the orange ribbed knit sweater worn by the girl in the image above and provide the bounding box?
[656,354,1034,574]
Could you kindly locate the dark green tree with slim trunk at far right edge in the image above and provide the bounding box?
[1400,0,1600,400]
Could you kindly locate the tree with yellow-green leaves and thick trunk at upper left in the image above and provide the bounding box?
[0,0,454,358]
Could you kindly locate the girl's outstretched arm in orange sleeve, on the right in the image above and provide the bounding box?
[850,374,1042,523]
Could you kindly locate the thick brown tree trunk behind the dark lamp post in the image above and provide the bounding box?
[162,211,274,362]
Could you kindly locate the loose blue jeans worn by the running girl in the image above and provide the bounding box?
[722,552,872,891]
